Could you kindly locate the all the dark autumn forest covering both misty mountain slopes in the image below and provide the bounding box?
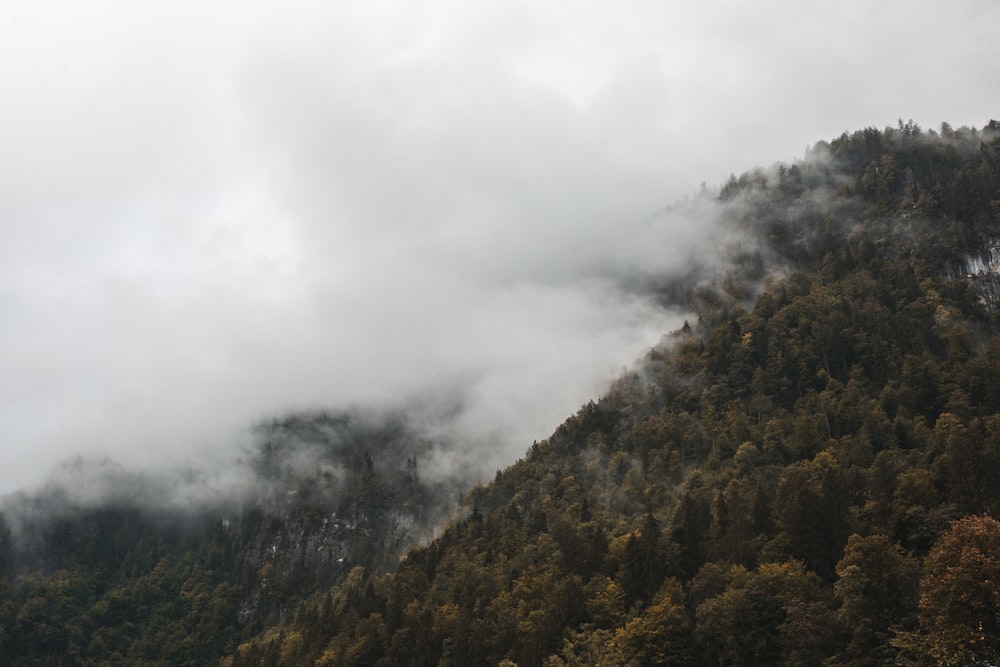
[0,121,1000,667]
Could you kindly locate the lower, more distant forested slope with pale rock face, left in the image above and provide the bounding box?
[0,412,468,665]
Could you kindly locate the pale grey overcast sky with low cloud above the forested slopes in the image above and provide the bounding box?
[0,0,1000,492]
